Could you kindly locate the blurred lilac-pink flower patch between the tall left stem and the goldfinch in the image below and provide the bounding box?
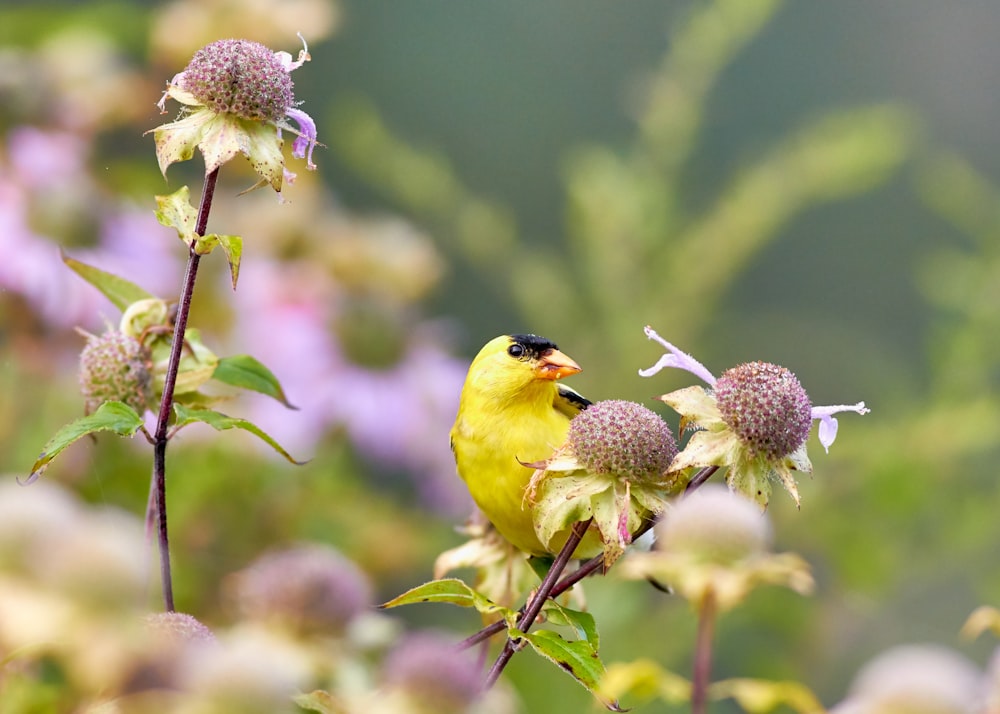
[231,262,470,514]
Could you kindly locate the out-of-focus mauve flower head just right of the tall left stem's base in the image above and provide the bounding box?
[233,545,371,633]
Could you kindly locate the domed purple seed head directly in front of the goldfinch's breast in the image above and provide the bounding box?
[568,399,677,482]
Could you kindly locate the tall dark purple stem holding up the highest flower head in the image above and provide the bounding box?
[150,169,219,612]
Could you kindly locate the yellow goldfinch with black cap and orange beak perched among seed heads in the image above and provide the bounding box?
[451,335,601,557]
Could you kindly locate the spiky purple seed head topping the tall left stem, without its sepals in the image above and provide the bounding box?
[180,40,295,122]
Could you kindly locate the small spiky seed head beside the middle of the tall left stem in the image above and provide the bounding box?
[80,330,153,414]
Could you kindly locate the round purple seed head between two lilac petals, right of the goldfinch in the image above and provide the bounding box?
[715,362,812,459]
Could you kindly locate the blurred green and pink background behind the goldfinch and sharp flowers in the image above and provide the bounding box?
[0,0,1000,711]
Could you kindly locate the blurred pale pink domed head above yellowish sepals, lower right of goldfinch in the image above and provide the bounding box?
[656,484,771,565]
